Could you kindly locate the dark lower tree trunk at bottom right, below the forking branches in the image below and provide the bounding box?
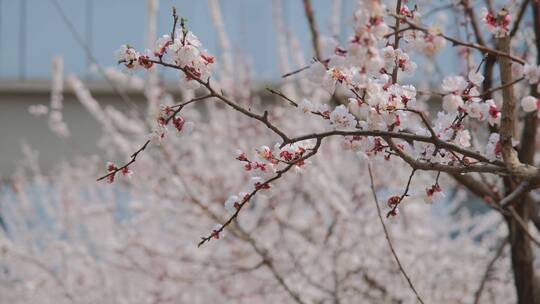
[506,200,540,304]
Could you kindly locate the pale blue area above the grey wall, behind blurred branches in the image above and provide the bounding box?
[0,0,353,79]
